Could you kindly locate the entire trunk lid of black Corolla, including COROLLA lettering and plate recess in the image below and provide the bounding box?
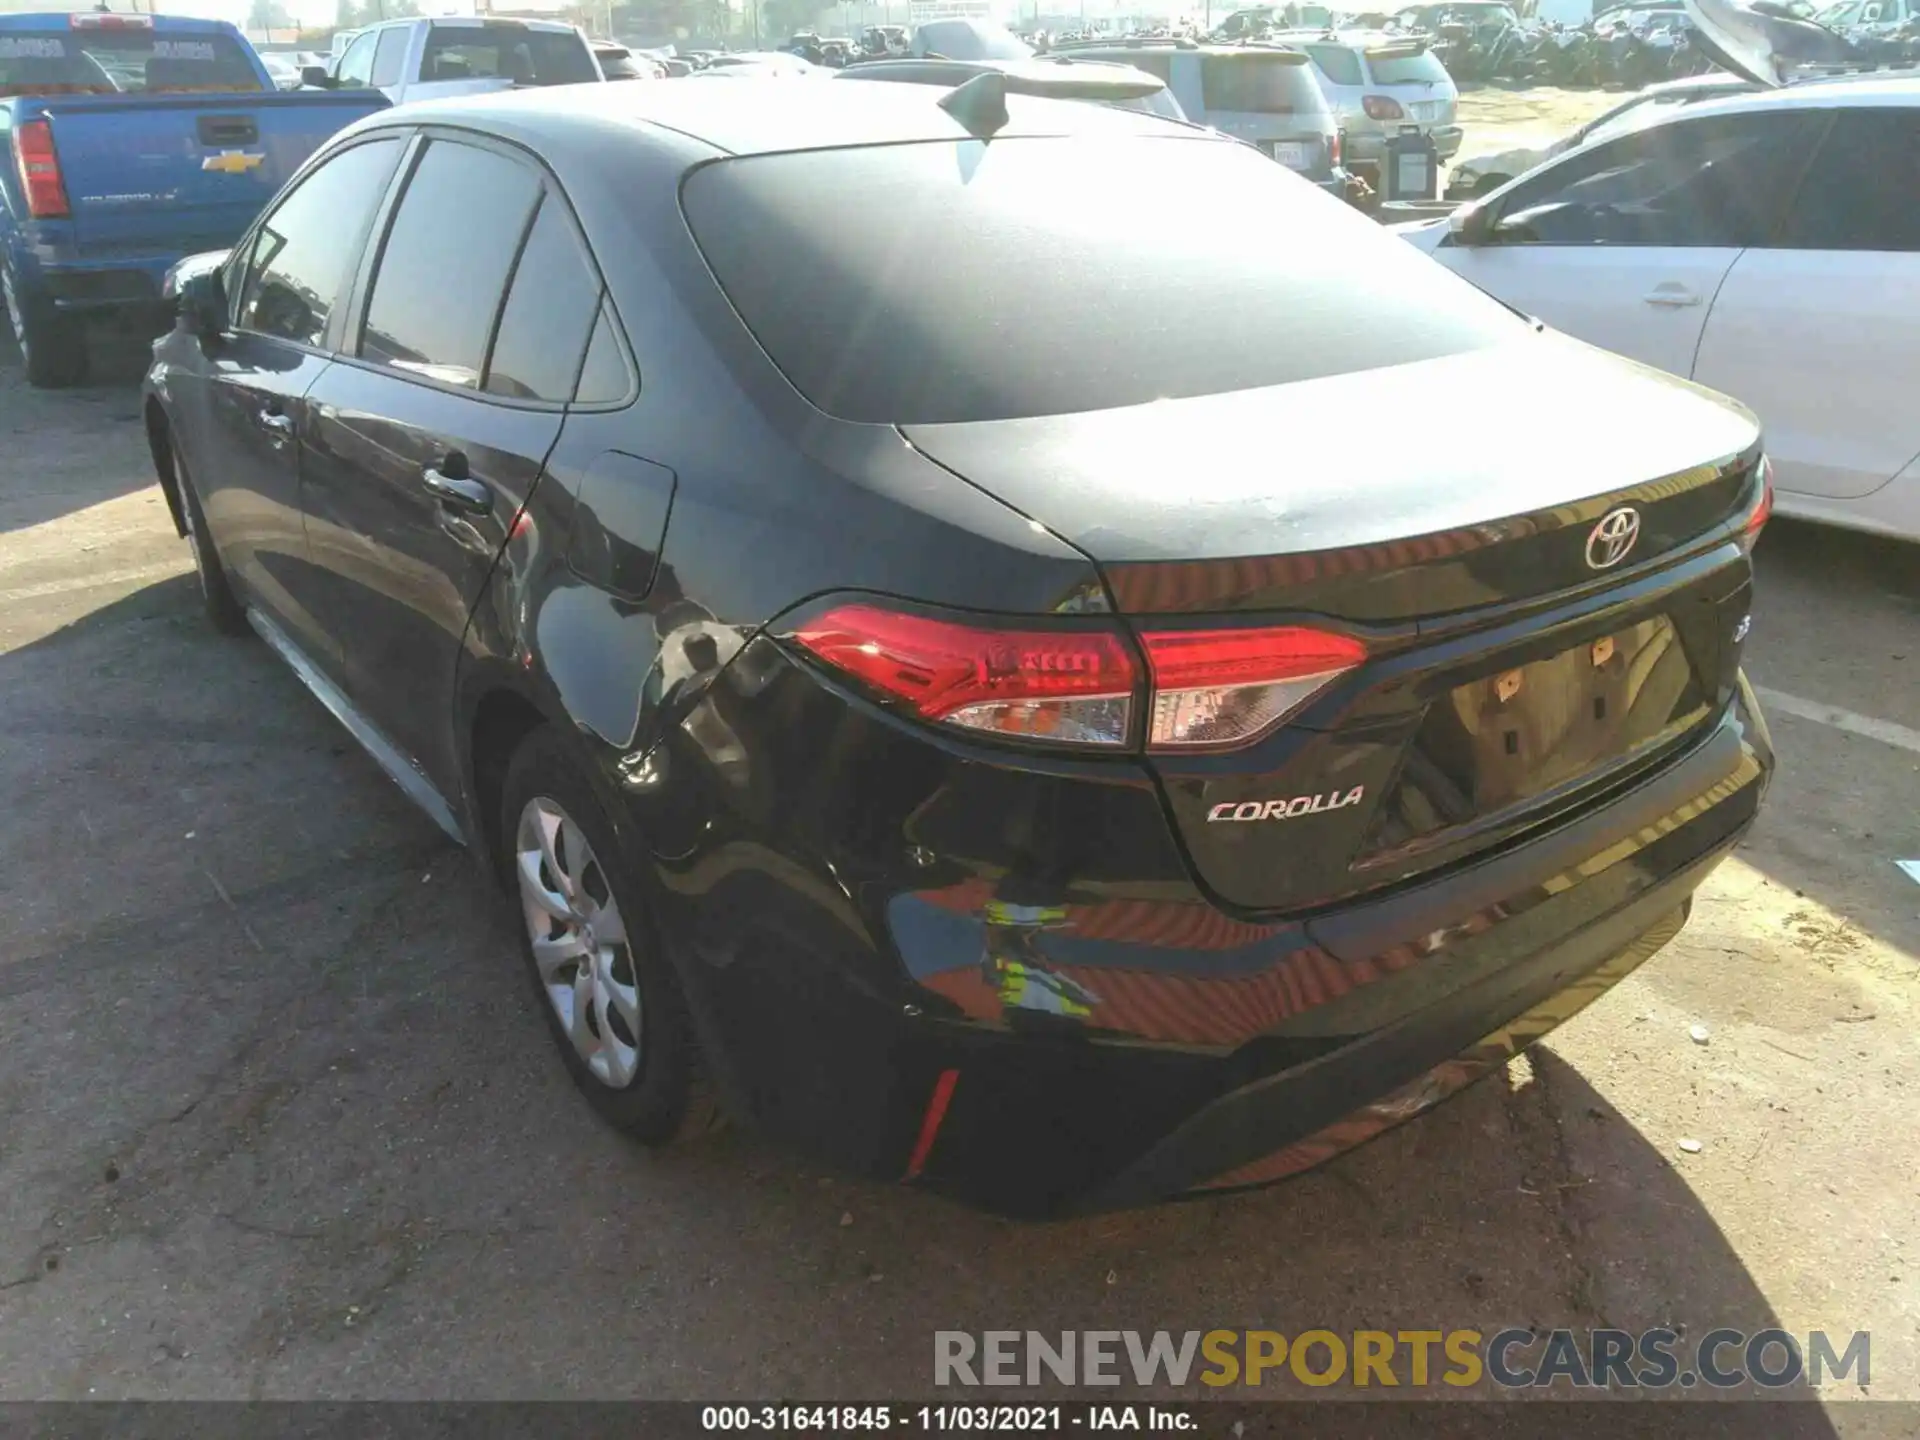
[906,336,1759,912]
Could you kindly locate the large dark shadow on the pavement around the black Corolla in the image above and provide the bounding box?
[0,576,1832,1413]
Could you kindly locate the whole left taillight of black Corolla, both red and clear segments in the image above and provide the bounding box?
[793,605,1367,751]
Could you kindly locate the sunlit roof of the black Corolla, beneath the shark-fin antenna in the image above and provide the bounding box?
[351,77,1200,156]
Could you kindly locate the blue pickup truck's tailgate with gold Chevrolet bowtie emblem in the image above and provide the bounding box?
[40,90,386,259]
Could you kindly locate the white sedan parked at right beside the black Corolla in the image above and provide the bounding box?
[1396,79,1920,540]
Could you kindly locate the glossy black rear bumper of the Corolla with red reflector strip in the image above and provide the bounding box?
[645,652,1772,1217]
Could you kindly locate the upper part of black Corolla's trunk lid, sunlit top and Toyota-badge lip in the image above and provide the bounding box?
[902,334,1759,624]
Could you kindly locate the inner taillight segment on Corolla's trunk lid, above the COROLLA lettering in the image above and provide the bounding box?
[1140,626,1367,751]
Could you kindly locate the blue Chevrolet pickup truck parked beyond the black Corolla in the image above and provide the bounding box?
[0,12,388,386]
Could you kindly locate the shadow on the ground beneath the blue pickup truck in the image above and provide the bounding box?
[0,343,154,534]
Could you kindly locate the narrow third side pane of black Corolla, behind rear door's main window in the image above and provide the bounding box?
[486,194,599,401]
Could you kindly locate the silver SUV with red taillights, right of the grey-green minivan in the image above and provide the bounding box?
[1273,31,1465,176]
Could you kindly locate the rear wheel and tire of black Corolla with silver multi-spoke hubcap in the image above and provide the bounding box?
[499,726,720,1146]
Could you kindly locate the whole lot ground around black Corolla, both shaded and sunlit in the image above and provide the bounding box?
[0,163,1920,1432]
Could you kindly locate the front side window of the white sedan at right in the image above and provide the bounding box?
[1494,111,1809,246]
